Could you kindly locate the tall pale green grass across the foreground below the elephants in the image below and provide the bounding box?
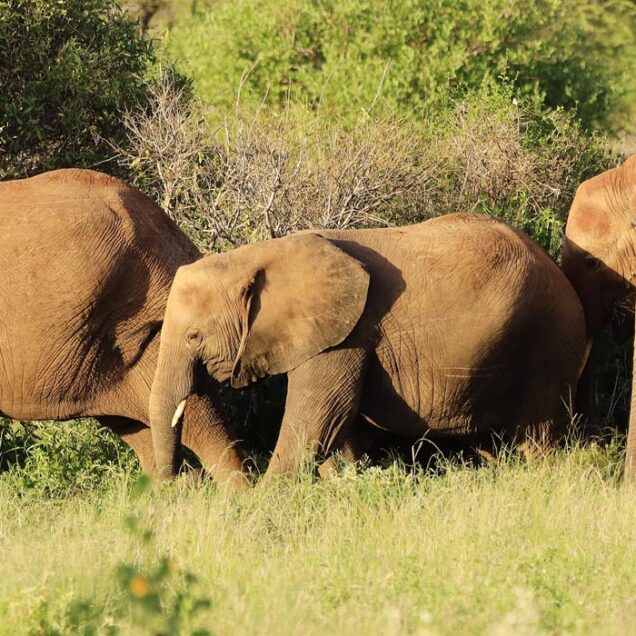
[0,443,636,634]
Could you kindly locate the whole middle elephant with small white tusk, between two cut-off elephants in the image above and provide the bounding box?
[150,214,585,477]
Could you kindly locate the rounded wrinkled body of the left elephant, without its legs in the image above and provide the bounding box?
[0,170,199,412]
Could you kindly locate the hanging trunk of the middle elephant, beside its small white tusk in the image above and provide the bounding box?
[150,337,194,479]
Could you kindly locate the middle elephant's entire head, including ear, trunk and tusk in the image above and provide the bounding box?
[150,234,369,476]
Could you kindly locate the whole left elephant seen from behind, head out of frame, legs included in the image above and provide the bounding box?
[0,170,246,484]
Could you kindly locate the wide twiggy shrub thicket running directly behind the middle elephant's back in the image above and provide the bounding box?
[114,77,609,255]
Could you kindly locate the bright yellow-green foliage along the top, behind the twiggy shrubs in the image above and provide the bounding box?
[168,0,636,128]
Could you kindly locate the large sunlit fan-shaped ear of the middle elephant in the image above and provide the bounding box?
[232,234,369,388]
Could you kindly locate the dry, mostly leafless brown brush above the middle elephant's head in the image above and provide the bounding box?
[115,72,427,250]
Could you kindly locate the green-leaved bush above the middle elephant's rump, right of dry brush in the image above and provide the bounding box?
[420,81,612,257]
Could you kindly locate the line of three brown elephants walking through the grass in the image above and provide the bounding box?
[0,157,636,488]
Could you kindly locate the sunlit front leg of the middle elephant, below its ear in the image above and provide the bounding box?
[264,348,368,481]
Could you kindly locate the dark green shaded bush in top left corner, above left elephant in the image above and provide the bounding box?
[0,0,154,178]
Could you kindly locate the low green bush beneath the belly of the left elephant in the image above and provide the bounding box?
[0,419,136,497]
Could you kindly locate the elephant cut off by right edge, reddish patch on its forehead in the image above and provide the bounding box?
[562,156,636,479]
